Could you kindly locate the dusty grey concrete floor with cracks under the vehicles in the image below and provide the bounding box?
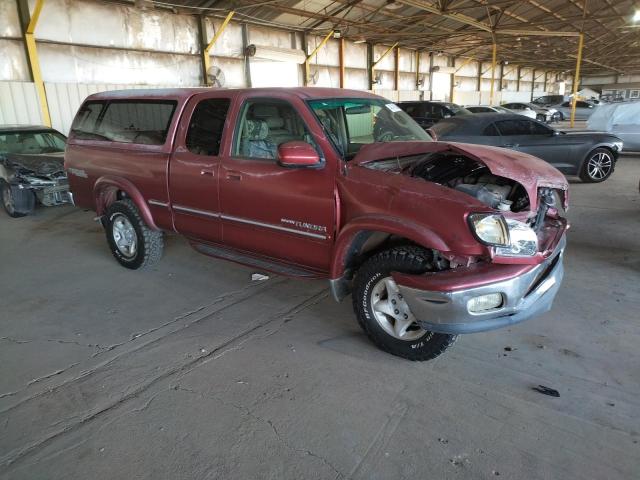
[0,156,640,480]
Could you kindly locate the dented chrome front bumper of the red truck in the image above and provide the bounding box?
[398,236,566,334]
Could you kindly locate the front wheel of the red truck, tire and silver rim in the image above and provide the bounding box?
[353,247,457,361]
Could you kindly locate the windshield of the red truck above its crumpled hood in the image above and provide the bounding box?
[309,98,432,160]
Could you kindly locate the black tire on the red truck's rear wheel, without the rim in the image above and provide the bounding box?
[104,199,164,270]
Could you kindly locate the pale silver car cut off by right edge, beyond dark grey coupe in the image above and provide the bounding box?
[587,102,640,152]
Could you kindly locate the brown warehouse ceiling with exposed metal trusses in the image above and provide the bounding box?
[145,0,640,74]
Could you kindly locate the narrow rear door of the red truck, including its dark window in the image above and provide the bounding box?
[169,94,231,242]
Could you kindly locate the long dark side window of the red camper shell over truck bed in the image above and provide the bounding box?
[72,100,177,145]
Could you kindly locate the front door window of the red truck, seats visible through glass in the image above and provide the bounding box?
[233,100,317,160]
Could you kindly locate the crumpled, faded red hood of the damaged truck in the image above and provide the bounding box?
[352,142,569,211]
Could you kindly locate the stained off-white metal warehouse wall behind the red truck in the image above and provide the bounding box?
[0,0,556,133]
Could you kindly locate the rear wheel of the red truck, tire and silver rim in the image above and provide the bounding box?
[104,199,163,270]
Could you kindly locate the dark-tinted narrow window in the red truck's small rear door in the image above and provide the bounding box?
[186,98,231,156]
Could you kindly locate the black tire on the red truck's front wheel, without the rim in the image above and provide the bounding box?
[352,246,458,361]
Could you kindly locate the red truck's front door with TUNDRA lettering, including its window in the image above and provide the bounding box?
[220,96,336,272]
